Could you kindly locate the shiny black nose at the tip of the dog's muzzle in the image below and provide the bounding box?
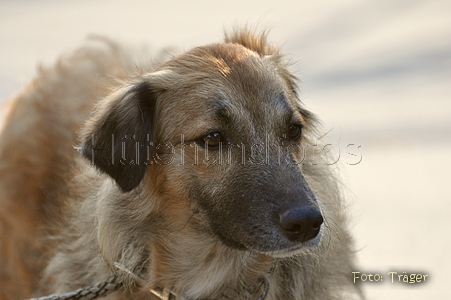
[280,206,323,242]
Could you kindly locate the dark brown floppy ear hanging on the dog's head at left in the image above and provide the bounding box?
[81,81,157,192]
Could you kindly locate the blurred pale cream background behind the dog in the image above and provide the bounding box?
[0,0,451,300]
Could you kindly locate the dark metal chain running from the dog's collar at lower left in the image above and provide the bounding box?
[29,275,122,300]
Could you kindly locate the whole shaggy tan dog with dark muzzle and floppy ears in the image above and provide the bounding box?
[0,29,363,300]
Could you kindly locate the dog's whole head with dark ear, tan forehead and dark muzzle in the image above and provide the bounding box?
[82,32,323,256]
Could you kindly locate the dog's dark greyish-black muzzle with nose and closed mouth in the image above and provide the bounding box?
[196,169,324,257]
